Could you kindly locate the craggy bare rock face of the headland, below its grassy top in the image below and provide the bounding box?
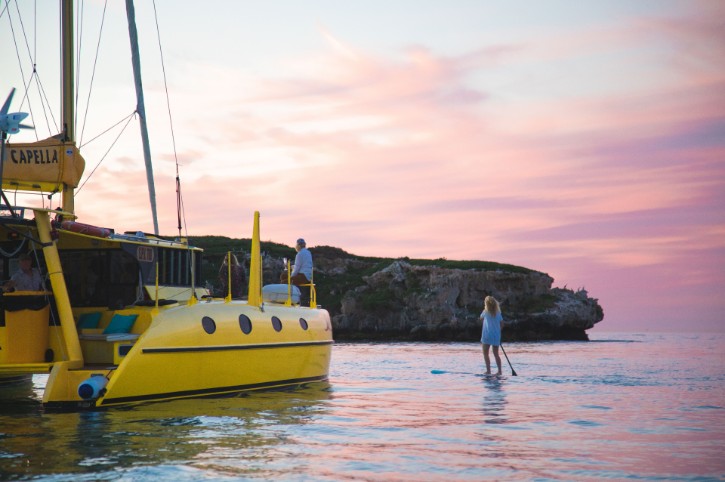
[326,261,603,340]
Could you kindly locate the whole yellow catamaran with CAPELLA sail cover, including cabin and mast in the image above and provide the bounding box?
[0,0,333,409]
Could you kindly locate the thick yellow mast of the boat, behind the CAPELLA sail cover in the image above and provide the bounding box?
[60,0,76,213]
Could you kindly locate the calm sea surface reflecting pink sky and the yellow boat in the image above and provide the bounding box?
[0,333,725,481]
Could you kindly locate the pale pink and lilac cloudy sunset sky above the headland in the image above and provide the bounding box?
[0,0,725,331]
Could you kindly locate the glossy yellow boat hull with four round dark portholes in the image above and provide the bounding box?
[43,300,333,408]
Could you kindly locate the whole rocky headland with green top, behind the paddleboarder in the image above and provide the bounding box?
[192,240,604,341]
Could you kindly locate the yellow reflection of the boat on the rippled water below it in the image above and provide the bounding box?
[0,383,330,480]
